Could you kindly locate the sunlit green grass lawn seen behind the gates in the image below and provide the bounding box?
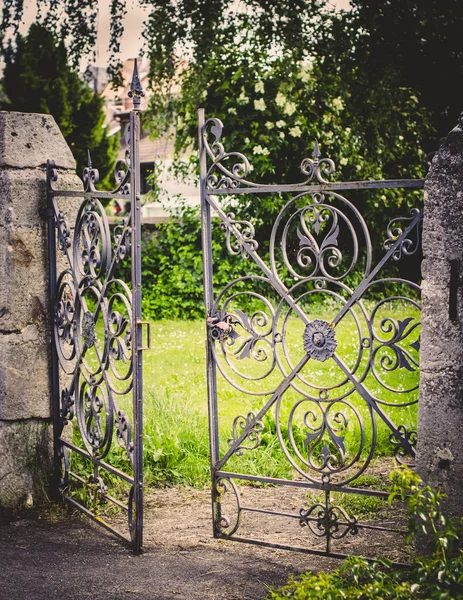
[68,306,418,492]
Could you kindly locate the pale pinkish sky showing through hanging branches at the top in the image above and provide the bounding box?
[17,0,349,67]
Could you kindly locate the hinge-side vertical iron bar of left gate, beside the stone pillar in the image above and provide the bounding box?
[46,160,62,499]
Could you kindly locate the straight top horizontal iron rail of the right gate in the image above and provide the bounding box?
[206,179,424,196]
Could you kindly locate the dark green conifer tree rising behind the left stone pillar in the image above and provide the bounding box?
[2,24,118,184]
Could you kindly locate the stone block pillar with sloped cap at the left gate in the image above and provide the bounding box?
[0,112,78,508]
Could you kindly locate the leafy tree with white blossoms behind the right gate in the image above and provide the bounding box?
[142,0,434,272]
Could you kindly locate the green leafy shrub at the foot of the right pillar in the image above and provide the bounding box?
[270,468,463,600]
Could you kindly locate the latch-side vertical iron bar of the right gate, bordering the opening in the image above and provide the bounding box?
[198,108,220,537]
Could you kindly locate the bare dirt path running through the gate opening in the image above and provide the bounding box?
[0,488,408,600]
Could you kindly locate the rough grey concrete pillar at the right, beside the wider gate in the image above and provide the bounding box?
[417,115,463,516]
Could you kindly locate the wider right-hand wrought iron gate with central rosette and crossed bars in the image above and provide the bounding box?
[199,109,424,558]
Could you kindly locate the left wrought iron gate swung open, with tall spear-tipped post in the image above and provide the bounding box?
[46,62,149,554]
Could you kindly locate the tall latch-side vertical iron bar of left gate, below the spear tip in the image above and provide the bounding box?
[130,102,143,554]
